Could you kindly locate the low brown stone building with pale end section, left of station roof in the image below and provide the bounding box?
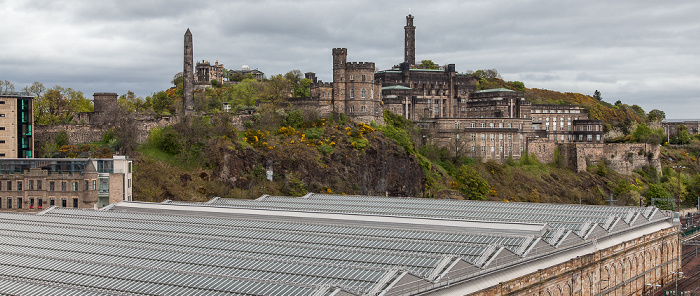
[0,156,132,210]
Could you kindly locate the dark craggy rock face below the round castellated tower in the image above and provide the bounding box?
[212,128,425,196]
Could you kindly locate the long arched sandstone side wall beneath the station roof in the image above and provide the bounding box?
[470,227,681,296]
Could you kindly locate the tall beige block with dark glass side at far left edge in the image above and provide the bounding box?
[0,93,34,159]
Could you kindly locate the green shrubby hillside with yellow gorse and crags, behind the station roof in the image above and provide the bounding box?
[134,110,700,209]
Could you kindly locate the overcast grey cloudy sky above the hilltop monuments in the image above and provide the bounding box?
[0,0,700,118]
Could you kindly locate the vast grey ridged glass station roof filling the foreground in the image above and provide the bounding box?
[0,194,673,296]
